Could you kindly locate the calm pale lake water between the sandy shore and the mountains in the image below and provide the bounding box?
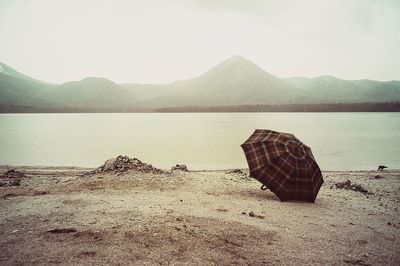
[0,113,400,170]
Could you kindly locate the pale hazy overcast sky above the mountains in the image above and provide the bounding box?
[0,0,400,83]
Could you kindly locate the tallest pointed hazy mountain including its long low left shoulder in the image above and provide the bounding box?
[125,56,301,107]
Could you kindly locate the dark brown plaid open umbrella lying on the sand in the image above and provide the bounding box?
[241,129,324,202]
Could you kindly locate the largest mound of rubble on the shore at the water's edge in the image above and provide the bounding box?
[88,155,164,174]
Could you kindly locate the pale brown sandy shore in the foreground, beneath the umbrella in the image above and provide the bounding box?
[0,167,400,265]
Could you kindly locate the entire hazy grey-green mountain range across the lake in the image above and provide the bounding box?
[0,56,400,112]
